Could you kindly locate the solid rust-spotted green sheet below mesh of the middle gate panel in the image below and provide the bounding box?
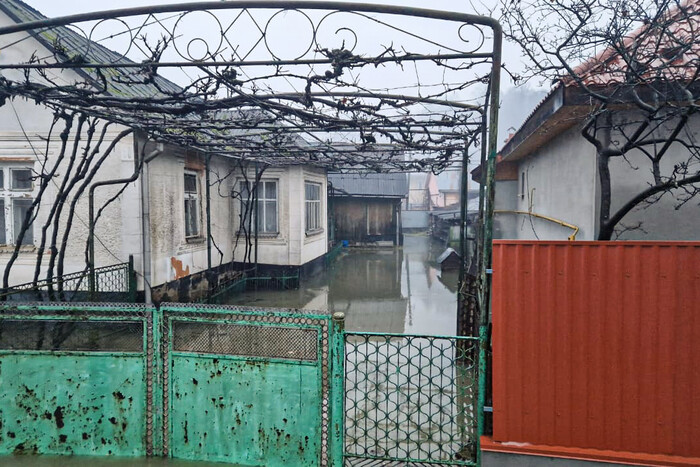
[170,354,322,465]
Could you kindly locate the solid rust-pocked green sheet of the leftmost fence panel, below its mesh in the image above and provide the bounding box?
[0,353,146,456]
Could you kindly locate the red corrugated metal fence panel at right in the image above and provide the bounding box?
[492,241,700,457]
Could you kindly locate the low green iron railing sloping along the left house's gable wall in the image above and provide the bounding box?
[0,256,136,303]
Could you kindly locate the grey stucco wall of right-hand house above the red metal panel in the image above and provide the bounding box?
[495,113,700,240]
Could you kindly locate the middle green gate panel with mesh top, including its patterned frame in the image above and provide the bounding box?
[161,305,340,466]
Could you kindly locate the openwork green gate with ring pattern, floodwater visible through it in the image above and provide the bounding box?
[344,332,479,466]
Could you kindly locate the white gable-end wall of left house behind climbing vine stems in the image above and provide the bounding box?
[0,13,141,285]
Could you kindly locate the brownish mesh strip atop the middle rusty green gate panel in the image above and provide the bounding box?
[173,322,318,362]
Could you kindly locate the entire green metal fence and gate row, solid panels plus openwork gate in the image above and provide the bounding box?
[0,303,479,466]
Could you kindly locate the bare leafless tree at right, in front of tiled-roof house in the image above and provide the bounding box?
[501,0,700,240]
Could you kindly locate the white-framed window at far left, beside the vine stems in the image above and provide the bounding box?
[0,167,34,245]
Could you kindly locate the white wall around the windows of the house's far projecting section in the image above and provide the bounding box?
[231,166,328,266]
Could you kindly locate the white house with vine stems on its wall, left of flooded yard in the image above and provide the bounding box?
[0,0,327,300]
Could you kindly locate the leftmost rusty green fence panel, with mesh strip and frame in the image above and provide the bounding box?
[0,304,154,456]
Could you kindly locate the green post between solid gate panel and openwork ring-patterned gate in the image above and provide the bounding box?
[329,312,345,467]
